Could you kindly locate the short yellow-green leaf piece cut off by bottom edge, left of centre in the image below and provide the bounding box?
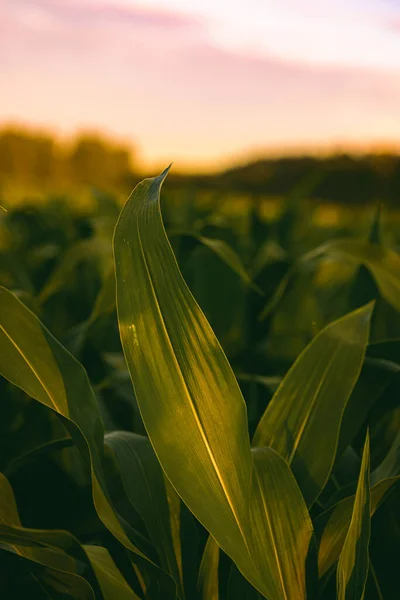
[84,545,139,600]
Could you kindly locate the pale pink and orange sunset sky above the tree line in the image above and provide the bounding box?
[0,0,400,169]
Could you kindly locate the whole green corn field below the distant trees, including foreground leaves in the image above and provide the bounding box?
[0,169,400,600]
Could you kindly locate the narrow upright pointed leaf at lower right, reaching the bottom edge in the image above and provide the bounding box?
[337,433,371,600]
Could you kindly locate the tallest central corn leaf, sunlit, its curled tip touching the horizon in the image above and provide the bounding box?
[114,172,252,570]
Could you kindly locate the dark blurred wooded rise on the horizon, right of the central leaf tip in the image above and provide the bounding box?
[165,154,400,206]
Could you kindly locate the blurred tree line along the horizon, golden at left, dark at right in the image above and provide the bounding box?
[0,127,400,204]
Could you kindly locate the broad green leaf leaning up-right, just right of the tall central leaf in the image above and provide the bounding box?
[253,304,373,505]
